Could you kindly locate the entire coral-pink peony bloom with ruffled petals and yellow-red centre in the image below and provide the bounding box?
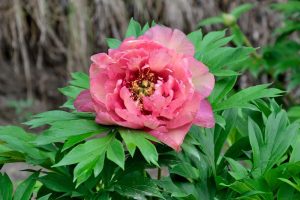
[74,25,215,151]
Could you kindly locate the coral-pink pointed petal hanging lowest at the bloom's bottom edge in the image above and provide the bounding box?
[150,124,192,151]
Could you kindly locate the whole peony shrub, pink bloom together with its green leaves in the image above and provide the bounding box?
[0,8,300,200]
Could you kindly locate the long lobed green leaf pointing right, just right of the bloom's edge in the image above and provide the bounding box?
[213,84,282,111]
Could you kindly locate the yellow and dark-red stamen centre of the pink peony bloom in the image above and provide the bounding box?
[129,68,157,101]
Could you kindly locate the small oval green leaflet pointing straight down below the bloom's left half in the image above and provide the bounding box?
[107,139,125,170]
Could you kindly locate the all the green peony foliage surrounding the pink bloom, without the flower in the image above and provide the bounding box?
[0,11,300,200]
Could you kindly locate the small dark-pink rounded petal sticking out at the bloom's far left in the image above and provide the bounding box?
[74,90,95,112]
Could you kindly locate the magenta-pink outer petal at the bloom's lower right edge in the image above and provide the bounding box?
[194,100,215,128]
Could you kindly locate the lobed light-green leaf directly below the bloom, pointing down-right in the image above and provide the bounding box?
[119,129,158,166]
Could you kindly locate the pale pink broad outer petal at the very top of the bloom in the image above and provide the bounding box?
[141,25,195,56]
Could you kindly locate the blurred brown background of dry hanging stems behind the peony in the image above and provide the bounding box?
[0,0,286,125]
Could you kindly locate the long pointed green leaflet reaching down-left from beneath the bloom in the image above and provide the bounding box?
[53,134,114,167]
